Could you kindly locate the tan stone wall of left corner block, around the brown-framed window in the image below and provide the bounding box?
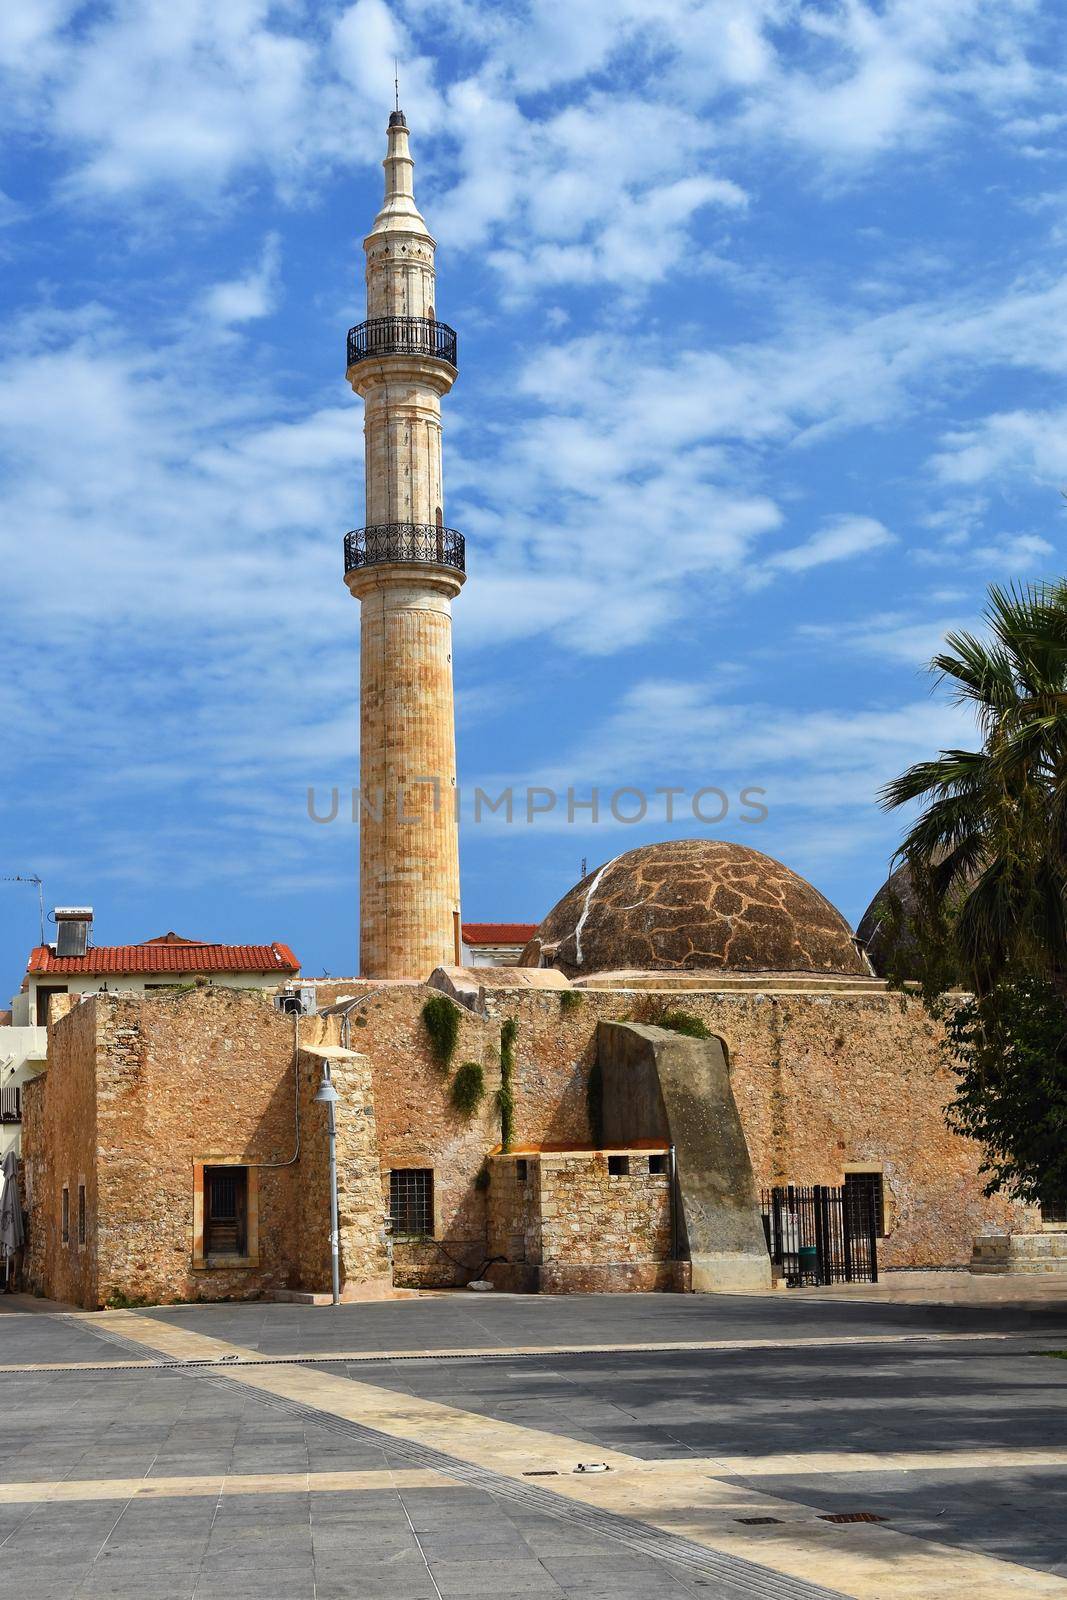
[24,987,387,1306]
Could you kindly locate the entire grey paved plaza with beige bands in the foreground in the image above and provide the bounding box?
[0,1291,1067,1600]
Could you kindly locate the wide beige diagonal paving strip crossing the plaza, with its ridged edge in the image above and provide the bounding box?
[64,1312,1067,1600]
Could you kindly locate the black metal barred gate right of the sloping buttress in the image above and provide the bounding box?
[761,1184,878,1288]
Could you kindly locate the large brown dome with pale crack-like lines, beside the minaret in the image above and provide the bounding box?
[522,838,870,978]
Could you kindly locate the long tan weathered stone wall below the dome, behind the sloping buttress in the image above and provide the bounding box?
[310,981,1033,1283]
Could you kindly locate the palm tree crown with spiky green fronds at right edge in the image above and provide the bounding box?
[881,581,1067,994]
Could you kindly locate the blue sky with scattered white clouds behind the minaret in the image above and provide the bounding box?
[0,0,1067,994]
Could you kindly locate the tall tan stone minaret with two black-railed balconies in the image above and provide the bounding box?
[344,109,466,978]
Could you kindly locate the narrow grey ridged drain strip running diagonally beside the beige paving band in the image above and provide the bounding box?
[68,1328,846,1600]
